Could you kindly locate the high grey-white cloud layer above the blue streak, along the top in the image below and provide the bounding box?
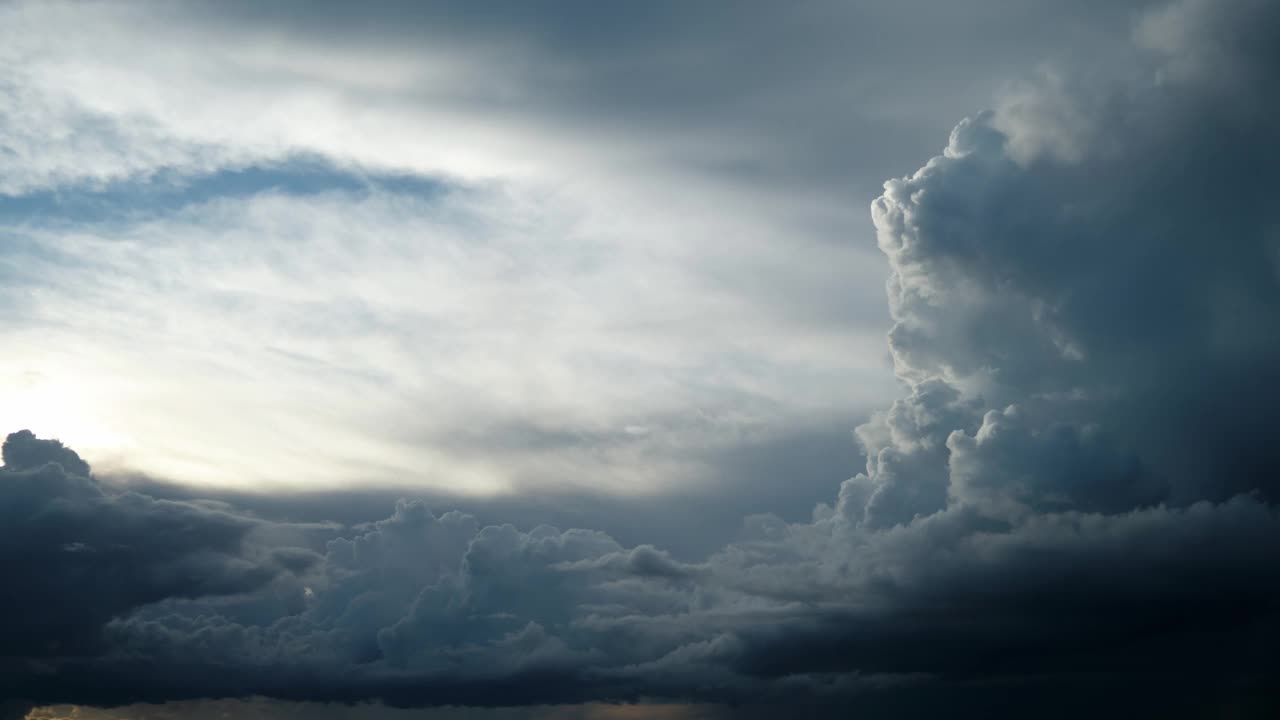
[0,0,1140,198]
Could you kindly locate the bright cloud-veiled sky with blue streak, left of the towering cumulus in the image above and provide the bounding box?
[0,3,1141,493]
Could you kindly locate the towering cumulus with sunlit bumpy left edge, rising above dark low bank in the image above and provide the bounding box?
[863,3,1280,515]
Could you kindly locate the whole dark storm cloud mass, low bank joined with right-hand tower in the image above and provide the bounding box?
[0,0,1280,717]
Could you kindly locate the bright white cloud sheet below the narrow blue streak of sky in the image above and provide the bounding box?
[0,178,890,495]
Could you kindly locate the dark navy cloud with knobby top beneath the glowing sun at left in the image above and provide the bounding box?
[0,430,311,671]
